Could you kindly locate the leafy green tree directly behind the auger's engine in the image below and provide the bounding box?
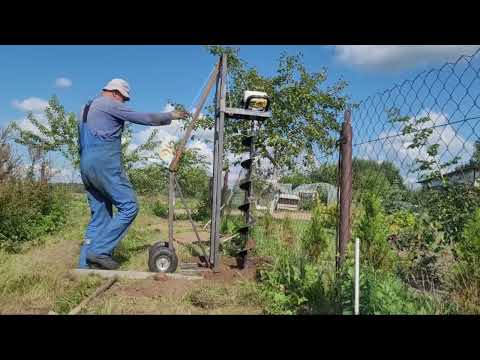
[200,46,348,176]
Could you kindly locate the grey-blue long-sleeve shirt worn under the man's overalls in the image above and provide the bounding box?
[78,95,173,139]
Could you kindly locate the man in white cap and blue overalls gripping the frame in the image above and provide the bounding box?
[78,79,188,270]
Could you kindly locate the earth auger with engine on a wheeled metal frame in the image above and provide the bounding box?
[148,55,271,273]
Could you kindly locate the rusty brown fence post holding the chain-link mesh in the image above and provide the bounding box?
[338,110,352,266]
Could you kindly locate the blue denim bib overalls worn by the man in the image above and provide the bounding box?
[78,101,138,268]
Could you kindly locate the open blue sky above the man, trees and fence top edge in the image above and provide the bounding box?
[0,45,478,183]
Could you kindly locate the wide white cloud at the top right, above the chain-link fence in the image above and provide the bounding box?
[335,45,480,70]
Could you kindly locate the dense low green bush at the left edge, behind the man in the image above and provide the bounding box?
[0,181,69,251]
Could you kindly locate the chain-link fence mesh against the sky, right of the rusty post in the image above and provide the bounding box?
[352,51,480,186]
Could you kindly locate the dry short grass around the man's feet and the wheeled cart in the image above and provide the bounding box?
[0,194,262,314]
